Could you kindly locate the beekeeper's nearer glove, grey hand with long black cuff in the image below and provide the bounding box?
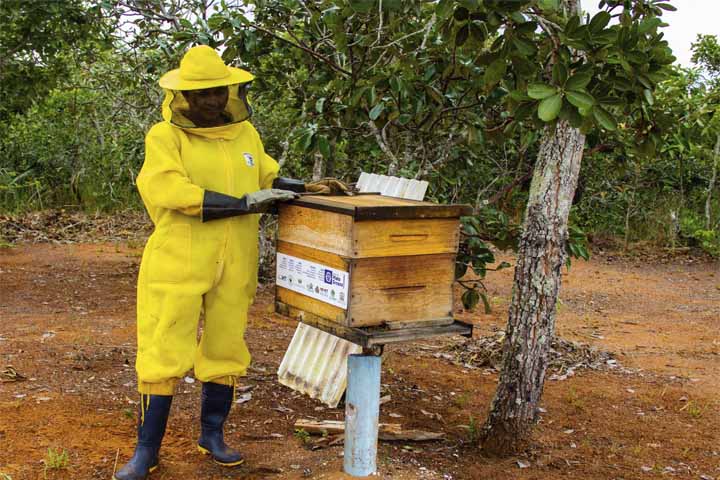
[202,188,299,222]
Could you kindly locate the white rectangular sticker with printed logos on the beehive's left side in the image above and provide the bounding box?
[275,253,349,309]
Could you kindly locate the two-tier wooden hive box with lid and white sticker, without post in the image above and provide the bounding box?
[276,194,471,328]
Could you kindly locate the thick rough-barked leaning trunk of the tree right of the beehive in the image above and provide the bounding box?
[482,121,585,455]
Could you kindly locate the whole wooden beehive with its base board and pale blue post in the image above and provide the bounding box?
[276,194,472,476]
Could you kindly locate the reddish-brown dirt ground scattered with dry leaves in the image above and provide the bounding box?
[0,244,720,480]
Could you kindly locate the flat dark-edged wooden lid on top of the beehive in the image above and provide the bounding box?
[290,194,472,220]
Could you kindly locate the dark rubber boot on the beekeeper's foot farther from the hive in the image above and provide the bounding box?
[113,395,172,480]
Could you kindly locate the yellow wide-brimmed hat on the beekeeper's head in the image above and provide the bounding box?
[158,45,255,90]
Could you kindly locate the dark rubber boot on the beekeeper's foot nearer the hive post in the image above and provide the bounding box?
[198,383,245,467]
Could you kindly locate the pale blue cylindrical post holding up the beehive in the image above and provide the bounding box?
[343,355,380,477]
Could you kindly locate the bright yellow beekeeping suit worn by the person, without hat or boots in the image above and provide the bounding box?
[136,72,279,395]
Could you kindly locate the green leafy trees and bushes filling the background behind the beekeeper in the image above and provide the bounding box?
[0,0,720,264]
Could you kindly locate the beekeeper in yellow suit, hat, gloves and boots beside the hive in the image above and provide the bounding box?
[114,46,347,480]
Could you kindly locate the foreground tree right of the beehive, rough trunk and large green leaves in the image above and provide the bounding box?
[430,0,674,453]
